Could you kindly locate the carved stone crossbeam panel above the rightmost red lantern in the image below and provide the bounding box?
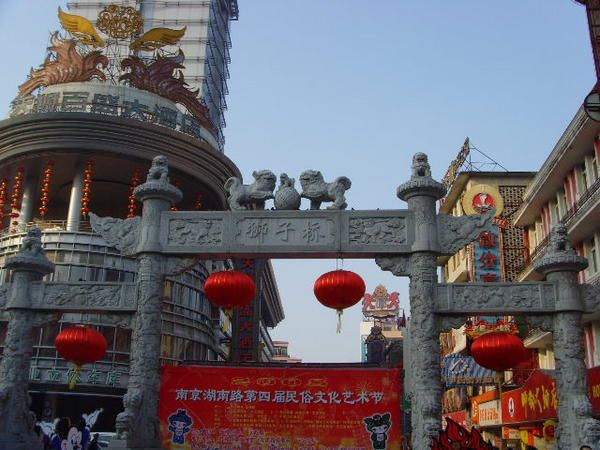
[435,282,557,315]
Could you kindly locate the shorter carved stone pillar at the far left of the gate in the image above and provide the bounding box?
[0,228,54,450]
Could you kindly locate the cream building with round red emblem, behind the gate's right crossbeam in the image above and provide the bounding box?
[439,166,553,449]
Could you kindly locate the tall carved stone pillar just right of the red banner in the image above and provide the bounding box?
[397,153,446,450]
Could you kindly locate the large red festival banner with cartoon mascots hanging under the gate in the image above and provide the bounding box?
[159,366,402,450]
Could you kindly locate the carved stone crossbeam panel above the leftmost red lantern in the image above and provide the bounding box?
[32,282,137,312]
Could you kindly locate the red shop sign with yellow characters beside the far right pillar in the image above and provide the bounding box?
[502,370,558,423]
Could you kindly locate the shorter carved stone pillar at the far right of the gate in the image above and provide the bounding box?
[534,224,600,449]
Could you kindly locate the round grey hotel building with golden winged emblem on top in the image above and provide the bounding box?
[0,1,283,430]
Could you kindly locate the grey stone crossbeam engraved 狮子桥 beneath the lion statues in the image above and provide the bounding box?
[161,210,414,258]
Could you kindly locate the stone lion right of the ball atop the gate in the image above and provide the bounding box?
[300,170,352,209]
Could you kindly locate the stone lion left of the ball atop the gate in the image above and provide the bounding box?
[225,170,277,211]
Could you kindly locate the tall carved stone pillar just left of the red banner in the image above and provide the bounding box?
[110,156,182,450]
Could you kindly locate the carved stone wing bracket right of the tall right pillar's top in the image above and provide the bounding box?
[438,209,496,255]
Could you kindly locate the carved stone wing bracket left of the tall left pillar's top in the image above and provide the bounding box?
[90,213,141,255]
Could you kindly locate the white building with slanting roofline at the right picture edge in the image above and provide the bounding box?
[514,107,600,428]
